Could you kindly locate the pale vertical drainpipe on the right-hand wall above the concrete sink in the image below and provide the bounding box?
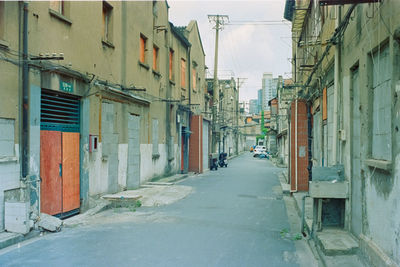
[332,6,341,164]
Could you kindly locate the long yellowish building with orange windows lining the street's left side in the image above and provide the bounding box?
[0,1,208,237]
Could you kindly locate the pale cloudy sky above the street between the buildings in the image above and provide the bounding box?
[168,0,292,101]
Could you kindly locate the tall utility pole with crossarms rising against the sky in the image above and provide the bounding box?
[208,15,229,153]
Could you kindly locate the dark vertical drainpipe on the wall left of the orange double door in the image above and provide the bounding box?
[21,2,29,178]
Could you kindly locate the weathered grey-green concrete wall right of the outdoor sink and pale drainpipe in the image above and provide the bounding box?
[340,1,400,265]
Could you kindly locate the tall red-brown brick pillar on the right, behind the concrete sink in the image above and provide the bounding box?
[290,100,308,191]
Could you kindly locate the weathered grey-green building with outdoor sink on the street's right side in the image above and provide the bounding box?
[285,0,400,266]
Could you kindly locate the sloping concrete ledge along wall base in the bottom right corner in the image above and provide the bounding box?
[360,234,399,267]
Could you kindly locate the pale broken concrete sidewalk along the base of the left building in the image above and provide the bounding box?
[0,173,194,249]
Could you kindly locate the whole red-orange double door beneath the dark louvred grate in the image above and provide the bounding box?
[40,130,80,215]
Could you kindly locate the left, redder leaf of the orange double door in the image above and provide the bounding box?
[40,131,62,215]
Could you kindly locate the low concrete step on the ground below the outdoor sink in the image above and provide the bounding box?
[317,229,358,256]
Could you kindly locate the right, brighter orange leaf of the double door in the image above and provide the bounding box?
[62,132,80,212]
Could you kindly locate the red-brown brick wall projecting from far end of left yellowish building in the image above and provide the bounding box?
[189,115,203,173]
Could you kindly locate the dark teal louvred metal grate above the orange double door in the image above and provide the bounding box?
[40,89,80,132]
